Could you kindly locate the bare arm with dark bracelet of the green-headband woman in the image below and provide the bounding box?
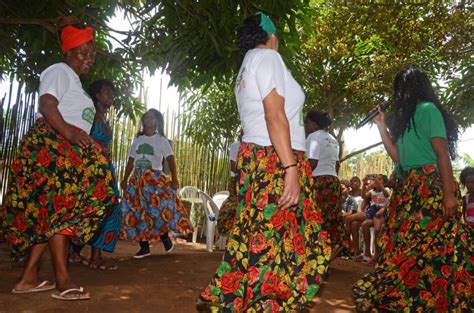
[263,89,300,209]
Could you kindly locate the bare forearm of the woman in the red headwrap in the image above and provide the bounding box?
[38,94,94,148]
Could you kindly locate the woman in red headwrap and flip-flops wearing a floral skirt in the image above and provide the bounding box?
[2,20,115,300]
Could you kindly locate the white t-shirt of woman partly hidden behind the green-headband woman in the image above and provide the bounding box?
[306,129,339,176]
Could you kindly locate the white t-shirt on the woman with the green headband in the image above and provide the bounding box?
[235,48,305,151]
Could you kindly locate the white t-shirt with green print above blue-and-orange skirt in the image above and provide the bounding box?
[129,134,173,171]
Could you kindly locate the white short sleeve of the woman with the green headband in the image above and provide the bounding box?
[255,51,285,99]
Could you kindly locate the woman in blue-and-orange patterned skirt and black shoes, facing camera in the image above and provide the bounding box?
[121,109,193,259]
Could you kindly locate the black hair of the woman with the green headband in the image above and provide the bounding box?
[237,14,268,54]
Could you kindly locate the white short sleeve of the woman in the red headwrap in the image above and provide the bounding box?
[39,66,70,102]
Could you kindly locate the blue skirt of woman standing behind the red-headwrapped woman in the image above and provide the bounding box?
[88,163,122,252]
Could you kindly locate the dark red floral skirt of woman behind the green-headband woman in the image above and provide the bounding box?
[313,175,352,254]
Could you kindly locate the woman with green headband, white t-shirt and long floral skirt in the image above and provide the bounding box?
[197,12,331,312]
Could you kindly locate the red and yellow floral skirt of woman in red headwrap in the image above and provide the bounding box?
[2,118,117,260]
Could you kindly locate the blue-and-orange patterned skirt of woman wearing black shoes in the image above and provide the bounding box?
[121,168,193,241]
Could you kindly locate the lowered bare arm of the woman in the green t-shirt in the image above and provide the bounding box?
[431,137,457,218]
